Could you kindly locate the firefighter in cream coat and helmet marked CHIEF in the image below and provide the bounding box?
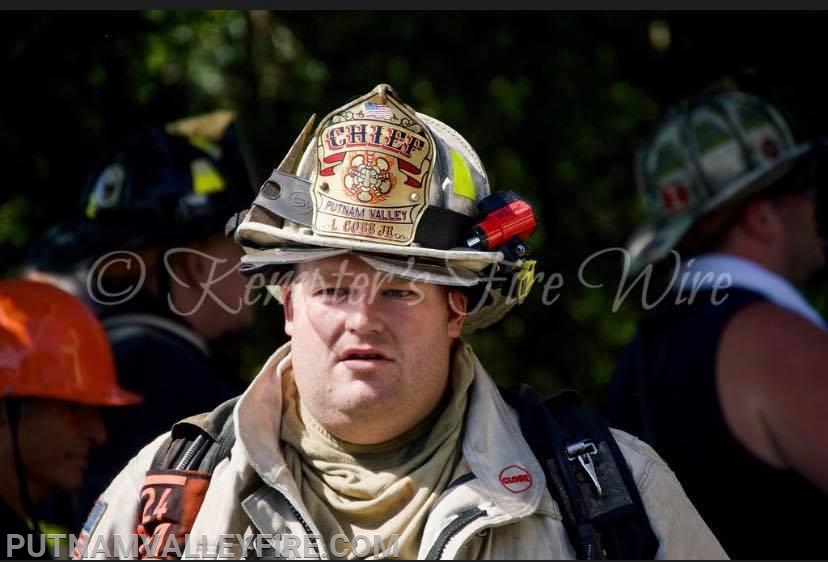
[79,84,724,559]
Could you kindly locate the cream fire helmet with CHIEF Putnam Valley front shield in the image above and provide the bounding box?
[235,84,535,333]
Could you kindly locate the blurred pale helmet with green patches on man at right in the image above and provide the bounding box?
[627,91,813,272]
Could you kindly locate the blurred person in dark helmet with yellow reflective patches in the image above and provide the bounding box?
[24,111,255,520]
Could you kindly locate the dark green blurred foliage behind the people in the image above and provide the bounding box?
[0,11,828,403]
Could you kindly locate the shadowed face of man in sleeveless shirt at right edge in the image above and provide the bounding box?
[774,192,825,282]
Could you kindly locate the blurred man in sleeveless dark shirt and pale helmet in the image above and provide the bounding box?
[606,91,828,559]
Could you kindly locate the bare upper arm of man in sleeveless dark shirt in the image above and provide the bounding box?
[716,302,828,488]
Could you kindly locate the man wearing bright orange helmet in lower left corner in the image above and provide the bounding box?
[0,279,141,558]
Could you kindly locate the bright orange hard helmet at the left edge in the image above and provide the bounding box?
[0,280,142,406]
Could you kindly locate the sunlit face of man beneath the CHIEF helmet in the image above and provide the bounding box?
[284,256,467,444]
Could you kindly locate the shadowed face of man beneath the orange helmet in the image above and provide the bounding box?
[13,399,106,497]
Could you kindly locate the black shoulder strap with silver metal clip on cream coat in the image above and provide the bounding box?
[500,385,658,560]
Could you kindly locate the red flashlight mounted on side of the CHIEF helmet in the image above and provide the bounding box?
[466,191,538,257]
